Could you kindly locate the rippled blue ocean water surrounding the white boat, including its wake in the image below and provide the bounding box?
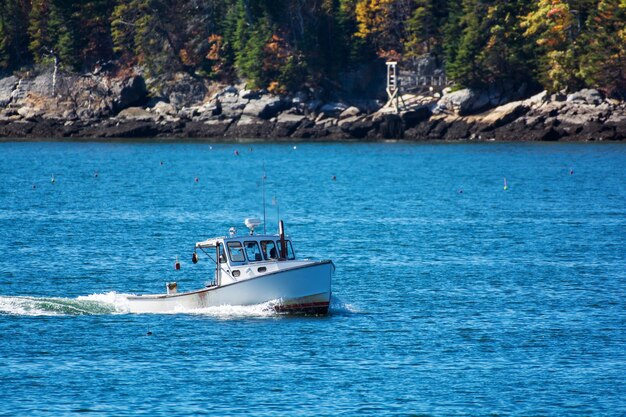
[0,143,626,416]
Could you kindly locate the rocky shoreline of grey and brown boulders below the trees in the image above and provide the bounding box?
[0,73,626,141]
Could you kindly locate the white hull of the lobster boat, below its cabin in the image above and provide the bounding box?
[128,261,334,314]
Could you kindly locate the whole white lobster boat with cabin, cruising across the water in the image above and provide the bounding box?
[127,219,335,314]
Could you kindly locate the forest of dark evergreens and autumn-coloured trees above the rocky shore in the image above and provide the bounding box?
[0,0,626,97]
